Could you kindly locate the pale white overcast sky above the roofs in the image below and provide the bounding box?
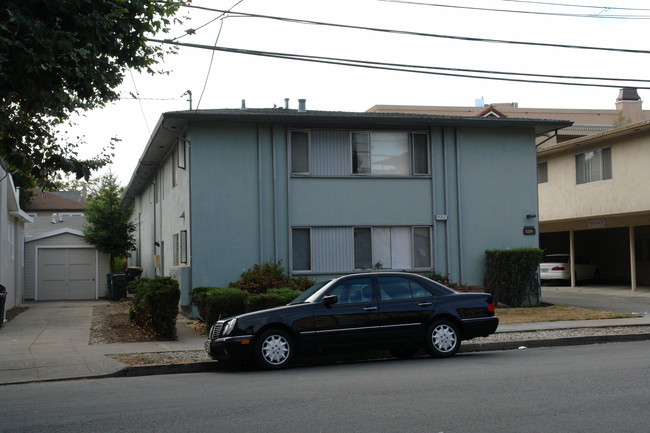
[67,0,650,186]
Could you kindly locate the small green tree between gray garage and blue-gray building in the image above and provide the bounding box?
[84,173,135,272]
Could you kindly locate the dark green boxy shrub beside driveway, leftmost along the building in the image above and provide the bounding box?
[128,277,181,339]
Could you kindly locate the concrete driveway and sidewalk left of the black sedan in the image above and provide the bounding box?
[0,300,204,384]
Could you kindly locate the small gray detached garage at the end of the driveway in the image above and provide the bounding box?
[25,228,109,301]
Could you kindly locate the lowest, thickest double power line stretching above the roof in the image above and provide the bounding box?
[148,39,650,90]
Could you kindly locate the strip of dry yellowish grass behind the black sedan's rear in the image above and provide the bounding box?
[496,304,637,324]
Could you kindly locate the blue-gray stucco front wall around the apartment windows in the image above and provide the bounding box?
[190,123,538,287]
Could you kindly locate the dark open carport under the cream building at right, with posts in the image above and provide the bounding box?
[540,215,650,291]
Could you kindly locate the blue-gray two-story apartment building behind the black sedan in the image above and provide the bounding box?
[124,102,569,305]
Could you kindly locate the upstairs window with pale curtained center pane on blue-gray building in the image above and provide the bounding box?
[351,132,429,176]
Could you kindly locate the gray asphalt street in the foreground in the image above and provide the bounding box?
[0,341,650,433]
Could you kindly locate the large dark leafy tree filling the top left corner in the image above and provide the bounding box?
[0,0,186,188]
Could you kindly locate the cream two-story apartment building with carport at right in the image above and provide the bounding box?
[538,120,650,290]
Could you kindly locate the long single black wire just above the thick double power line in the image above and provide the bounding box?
[180,5,650,54]
